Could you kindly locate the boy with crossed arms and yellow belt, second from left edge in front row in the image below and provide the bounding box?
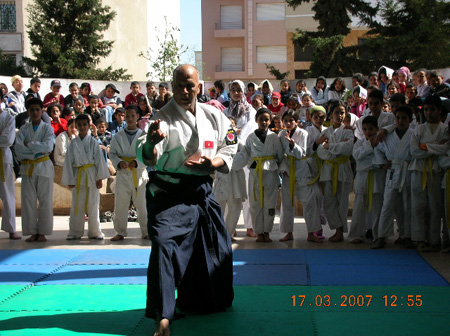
[16,98,55,242]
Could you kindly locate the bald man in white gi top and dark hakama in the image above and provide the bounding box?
[137,65,237,336]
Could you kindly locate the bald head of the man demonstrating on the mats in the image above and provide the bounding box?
[172,64,200,113]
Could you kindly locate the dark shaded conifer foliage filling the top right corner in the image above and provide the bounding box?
[368,0,450,69]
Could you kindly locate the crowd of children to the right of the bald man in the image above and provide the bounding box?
[215,70,450,251]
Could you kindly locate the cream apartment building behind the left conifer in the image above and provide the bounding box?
[0,0,180,81]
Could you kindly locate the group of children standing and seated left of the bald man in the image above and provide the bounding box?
[0,76,157,242]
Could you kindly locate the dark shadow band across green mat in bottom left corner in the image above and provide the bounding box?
[0,309,144,335]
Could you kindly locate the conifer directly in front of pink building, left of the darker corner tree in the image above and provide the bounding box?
[286,0,377,77]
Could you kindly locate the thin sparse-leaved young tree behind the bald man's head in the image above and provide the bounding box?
[138,17,188,82]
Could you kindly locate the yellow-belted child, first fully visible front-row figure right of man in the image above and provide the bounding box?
[232,108,284,242]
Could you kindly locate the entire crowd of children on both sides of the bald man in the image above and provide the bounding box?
[0,67,450,251]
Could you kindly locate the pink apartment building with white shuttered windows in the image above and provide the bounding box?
[202,0,367,81]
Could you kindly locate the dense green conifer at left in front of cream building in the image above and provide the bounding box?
[24,0,130,80]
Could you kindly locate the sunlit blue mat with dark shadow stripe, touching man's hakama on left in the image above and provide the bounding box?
[38,265,147,285]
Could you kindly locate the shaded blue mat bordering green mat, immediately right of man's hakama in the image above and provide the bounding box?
[233,265,308,286]
